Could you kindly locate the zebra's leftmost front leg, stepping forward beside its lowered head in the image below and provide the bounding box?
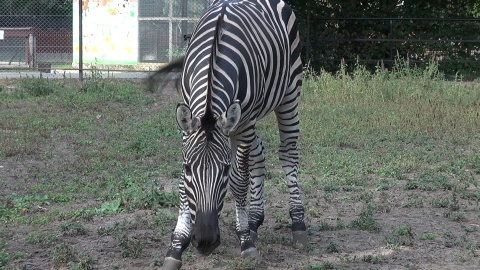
[161,180,191,270]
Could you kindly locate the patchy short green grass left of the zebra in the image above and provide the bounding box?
[0,79,178,220]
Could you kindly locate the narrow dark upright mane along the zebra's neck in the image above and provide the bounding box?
[201,15,222,140]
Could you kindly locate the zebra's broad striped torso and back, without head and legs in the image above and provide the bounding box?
[182,0,296,131]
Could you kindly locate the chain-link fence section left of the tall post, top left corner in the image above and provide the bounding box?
[0,0,72,69]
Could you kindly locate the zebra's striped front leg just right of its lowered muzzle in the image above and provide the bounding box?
[229,138,261,261]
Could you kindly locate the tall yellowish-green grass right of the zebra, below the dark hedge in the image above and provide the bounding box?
[294,63,480,181]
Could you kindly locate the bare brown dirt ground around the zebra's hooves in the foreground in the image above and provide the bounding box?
[2,173,480,270]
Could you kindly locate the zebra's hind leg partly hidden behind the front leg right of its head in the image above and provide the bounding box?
[248,136,265,242]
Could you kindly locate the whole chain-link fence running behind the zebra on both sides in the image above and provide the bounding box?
[0,0,480,75]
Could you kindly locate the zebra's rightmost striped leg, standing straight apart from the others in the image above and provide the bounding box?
[275,102,308,247]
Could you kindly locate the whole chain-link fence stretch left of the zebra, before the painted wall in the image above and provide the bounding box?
[0,0,212,73]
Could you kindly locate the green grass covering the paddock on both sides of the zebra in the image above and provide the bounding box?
[0,63,480,269]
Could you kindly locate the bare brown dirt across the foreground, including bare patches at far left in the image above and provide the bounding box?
[0,79,480,270]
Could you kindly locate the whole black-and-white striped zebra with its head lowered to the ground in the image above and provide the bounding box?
[149,0,307,269]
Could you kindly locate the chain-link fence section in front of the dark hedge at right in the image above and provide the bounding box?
[302,17,480,77]
